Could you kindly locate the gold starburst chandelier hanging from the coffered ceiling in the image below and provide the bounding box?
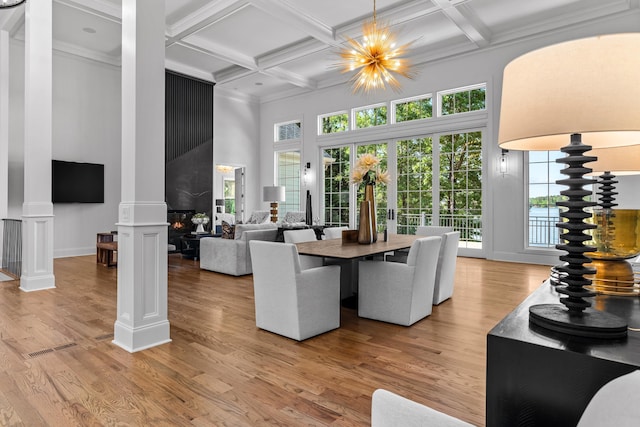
[340,0,413,93]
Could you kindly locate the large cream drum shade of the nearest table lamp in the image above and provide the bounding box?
[498,33,640,151]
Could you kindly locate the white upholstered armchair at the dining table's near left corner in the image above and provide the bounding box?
[249,240,340,341]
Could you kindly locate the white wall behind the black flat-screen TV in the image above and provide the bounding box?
[8,42,121,257]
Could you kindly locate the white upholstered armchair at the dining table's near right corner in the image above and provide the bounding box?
[358,236,442,326]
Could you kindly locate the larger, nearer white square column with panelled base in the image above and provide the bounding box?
[113,0,171,352]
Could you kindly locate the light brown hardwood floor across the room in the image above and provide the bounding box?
[0,255,549,426]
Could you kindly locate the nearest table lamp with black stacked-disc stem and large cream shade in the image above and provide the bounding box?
[498,33,640,338]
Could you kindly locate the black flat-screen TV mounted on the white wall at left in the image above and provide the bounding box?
[51,160,104,203]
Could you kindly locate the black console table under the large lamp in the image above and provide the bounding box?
[486,279,640,427]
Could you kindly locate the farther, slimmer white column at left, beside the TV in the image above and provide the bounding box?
[20,0,55,291]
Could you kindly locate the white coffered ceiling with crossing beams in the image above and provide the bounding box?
[0,0,640,101]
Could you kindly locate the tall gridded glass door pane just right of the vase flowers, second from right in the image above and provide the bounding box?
[396,137,433,234]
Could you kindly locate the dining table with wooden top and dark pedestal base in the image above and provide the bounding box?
[296,234,424,308]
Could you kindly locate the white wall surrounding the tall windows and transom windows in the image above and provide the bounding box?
[260,10,640,264]
